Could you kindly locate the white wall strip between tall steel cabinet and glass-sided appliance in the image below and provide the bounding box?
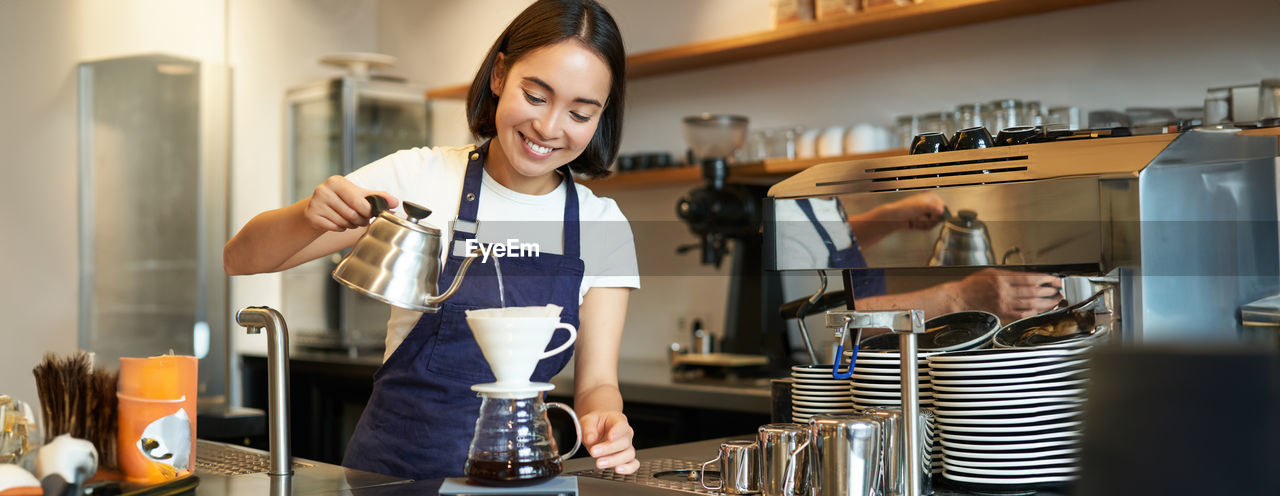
[229,0,376,354]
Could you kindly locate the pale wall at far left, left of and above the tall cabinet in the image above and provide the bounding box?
[0,0,224,411]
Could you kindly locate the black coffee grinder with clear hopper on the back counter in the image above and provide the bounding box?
[676,114,790,368]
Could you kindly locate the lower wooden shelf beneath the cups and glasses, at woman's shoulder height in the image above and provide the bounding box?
[582,150,906,193]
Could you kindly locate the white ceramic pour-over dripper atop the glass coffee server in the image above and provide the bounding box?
[467,304,577,386]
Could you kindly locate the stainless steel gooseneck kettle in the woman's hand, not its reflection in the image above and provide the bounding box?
[333,196,476,313]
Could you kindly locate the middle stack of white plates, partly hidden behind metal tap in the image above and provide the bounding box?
[844,352,942,473]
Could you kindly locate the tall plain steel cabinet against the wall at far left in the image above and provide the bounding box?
[78,55,229,399]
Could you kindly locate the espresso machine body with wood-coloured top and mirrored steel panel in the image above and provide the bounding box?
[764,130,1280,343]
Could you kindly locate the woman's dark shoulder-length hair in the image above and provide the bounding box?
[467,0,627,178]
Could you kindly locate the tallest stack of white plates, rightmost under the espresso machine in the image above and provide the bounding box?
[928,341,1089,492]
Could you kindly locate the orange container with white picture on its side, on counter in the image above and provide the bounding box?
[116,355,198,483]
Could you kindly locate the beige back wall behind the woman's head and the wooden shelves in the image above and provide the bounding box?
[378,0,1280,360]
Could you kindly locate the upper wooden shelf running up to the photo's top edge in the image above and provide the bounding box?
[426,0,1119,100]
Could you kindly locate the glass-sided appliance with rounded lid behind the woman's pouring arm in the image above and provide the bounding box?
[282,54,431,354]
